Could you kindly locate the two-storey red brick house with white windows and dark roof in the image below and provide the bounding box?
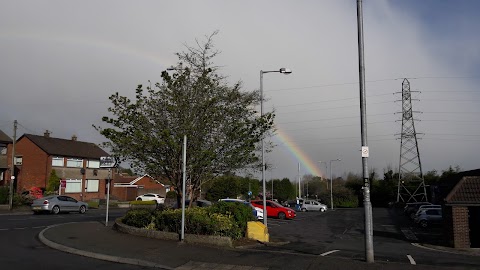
[15,130,110,201]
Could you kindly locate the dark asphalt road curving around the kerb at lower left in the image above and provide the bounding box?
[0,210,156,270]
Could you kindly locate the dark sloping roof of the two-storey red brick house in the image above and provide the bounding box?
[18,134,109,159]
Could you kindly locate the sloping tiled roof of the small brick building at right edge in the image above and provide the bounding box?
[445,176,480,204]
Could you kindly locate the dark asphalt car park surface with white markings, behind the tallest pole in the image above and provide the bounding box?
[260,208,480,269]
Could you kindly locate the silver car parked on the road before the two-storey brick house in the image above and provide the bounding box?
[30,195,88,214]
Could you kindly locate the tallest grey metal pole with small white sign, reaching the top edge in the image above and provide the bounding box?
[357,0,374,263]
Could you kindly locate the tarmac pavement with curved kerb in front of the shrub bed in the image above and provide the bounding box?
[39,219,480,270]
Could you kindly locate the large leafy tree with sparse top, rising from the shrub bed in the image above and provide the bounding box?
[95,33,274,199]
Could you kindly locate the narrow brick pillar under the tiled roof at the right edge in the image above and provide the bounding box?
[452,206,470,248]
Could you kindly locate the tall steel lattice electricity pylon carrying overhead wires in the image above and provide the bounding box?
[397,79,427,202]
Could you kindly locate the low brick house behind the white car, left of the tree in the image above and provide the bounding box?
[111,174,170,201]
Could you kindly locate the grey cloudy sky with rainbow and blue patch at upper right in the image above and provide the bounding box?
[0,0,480,180]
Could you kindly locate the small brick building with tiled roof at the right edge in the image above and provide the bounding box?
[443,173,480,248]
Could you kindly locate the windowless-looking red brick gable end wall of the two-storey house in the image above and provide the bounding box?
[15,137,52,192]
